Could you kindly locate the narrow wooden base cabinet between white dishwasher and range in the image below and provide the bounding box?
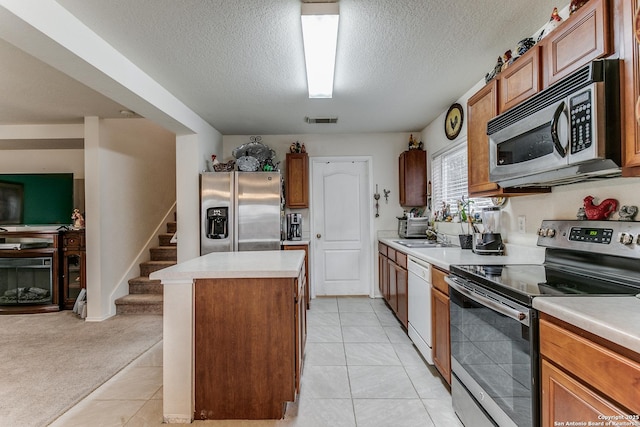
[431,267,451,384]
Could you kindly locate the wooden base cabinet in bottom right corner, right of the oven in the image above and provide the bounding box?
[540,314,640,427]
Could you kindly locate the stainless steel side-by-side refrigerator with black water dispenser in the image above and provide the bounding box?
[200,172,282,255]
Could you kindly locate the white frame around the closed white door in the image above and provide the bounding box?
[309,156,378,298]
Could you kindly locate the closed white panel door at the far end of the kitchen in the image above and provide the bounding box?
[311,158,373,295]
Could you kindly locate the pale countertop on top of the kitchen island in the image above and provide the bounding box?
[149,250,304,285]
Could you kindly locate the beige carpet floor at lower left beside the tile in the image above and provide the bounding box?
[0,311,162,427]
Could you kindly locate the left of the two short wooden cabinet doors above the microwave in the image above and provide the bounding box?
[498,46,542,112]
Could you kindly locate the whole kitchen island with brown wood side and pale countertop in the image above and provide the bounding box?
[150,251,306,423]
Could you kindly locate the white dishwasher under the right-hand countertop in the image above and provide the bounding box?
[407,256,433,365]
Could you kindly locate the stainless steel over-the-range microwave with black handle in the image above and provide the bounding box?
[487,59,621,187]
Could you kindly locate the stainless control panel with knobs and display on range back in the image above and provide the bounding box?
[538,220,640,259]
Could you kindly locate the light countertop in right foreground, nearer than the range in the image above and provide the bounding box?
[533,296,640,354]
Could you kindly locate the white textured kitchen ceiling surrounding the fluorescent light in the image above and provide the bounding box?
[0,0,568,135]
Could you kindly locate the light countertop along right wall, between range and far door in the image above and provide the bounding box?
[378,237,544,270]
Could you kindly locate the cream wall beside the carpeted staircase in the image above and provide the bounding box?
[85,118,176,320]
